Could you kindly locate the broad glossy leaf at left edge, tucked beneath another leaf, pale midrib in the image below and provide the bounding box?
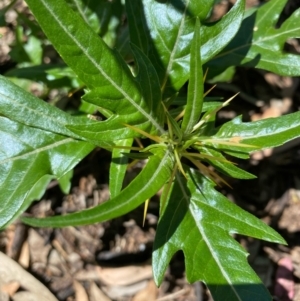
[0,117,94,227]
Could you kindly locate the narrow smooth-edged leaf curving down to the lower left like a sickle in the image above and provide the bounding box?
[23,146,174,227]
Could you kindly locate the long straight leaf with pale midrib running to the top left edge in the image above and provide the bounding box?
[27,0,163,139]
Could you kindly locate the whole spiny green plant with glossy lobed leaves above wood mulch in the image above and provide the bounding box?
[0,0,300,301]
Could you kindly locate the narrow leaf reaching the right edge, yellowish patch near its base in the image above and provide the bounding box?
[210,112,300,153]
